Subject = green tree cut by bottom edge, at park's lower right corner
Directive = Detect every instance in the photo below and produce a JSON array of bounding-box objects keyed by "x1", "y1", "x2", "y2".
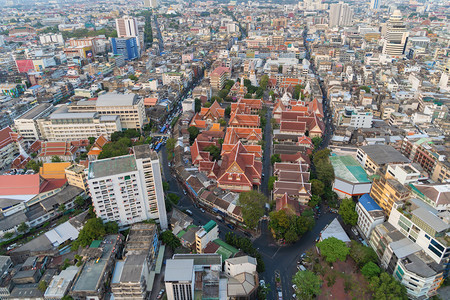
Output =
[{"x1": 369, "y1": 272, "x2": 408, "y2": 300}]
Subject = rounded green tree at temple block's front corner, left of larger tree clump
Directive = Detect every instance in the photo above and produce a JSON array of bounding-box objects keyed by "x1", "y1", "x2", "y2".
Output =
[{"x1": 238, "y1": 191, "x2": 267, "y2": 229}]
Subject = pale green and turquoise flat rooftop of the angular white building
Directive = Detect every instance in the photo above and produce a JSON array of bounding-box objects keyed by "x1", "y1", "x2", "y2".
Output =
[{"x1": 330, "y1": 155, "x2": 370, "y2": 183}]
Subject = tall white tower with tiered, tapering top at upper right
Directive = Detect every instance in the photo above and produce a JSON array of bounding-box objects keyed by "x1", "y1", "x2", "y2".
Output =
[{"x1": 383, "y1": 10, "x2": 409, "y2": 57}]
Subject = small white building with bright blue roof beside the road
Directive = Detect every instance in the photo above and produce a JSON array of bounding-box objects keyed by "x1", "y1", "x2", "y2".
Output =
[{"x1": 356, "y1": 194, "x2": 384, "y2": 238}]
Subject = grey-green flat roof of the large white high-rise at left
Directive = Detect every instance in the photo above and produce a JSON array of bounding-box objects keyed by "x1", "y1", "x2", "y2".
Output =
[{"x1": 88, "y1": 155, "x2": 137, "y2": 179}]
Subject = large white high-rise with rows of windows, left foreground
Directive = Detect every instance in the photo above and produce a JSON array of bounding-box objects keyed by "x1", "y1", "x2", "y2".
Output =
[{"x1": 87, "y1": 145, "x2": 167, "y2": 229}]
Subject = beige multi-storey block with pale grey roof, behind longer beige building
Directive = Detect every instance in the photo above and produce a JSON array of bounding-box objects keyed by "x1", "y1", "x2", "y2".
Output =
[{"x1": 69, "y1": 93, "x2": 147, "y2": 129}]
